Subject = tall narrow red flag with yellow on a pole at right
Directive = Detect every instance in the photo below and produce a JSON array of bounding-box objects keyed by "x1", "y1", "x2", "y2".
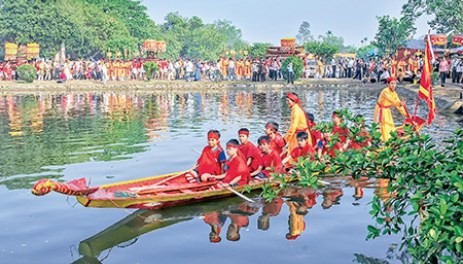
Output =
[{"x1": 418, "y1": 35, "x2": 436, "y2": 125}]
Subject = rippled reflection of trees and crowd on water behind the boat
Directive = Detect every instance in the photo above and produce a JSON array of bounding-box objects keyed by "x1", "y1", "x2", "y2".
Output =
[{"x1": 0, "y1": 88, "x2": 457, "y2": 190}]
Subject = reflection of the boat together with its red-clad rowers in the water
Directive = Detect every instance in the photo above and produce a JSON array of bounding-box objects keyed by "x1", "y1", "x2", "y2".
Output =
[{"x1": 74, "y1": 182, "x2": 406, "y2": 263}]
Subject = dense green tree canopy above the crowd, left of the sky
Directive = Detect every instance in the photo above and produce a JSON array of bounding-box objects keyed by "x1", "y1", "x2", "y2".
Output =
[{"x1": 0, "y1": 0, "x2": 248, "y2": 60}]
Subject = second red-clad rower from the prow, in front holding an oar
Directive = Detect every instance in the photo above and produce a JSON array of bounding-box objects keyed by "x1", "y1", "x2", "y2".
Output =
[{"x1": 201, "y1": 139, "x2": 251, "y2": 189}]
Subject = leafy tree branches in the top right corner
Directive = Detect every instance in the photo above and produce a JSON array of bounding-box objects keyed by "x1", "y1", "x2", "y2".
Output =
[{"x1": 402, "y1": 0, "x2": 463, "y2": 34}]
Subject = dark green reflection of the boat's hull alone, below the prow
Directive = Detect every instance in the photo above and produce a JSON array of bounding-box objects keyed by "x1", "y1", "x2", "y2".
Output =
[{"x1": 74, "y1": 198, "x2": 246, "y2": 263}]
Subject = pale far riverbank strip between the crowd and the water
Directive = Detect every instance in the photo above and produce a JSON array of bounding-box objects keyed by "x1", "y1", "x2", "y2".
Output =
[{"x1": 0, "y1": 79, "x2": 463, "y2": 114}]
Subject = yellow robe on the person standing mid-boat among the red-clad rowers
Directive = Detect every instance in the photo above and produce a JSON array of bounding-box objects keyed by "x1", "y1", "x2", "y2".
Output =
[{"x1": 285, "y1": 104, "x2": 312, "y2": 154}]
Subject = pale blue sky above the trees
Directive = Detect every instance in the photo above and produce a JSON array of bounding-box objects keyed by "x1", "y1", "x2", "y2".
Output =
[{"x1": 142, "y1": 0, "x2": 429, "y2": 46}]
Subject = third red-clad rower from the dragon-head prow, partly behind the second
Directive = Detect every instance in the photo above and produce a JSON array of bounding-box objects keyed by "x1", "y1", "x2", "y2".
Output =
[{"x1": 238, "y1": 128, "x2": 262, "y2": 178}]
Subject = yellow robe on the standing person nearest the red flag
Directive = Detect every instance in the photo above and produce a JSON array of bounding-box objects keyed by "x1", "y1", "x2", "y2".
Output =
[{"x1": 373, "y1": 88, "x2": 406, "y2": 141}]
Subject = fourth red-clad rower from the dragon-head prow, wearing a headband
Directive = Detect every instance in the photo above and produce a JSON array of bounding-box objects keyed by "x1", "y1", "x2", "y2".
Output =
[{"x1": 257, "y1": 136, "x2": 283, "y2": 178}]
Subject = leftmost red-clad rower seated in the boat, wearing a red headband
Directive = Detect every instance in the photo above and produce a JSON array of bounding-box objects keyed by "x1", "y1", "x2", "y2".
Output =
[{"x1": 185, "y1": 130, "x2": 227, "y2": 183}]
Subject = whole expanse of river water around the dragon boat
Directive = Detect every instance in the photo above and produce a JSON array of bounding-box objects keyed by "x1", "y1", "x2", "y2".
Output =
[{"x1": 0, "y1": 87, "x2": 459, "y2": 264}]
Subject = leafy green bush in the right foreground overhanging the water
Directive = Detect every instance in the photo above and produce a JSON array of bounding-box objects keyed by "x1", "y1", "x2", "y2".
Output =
[{"x1": 264, "y1": 107, "x2": 463, "y2": 263}]
